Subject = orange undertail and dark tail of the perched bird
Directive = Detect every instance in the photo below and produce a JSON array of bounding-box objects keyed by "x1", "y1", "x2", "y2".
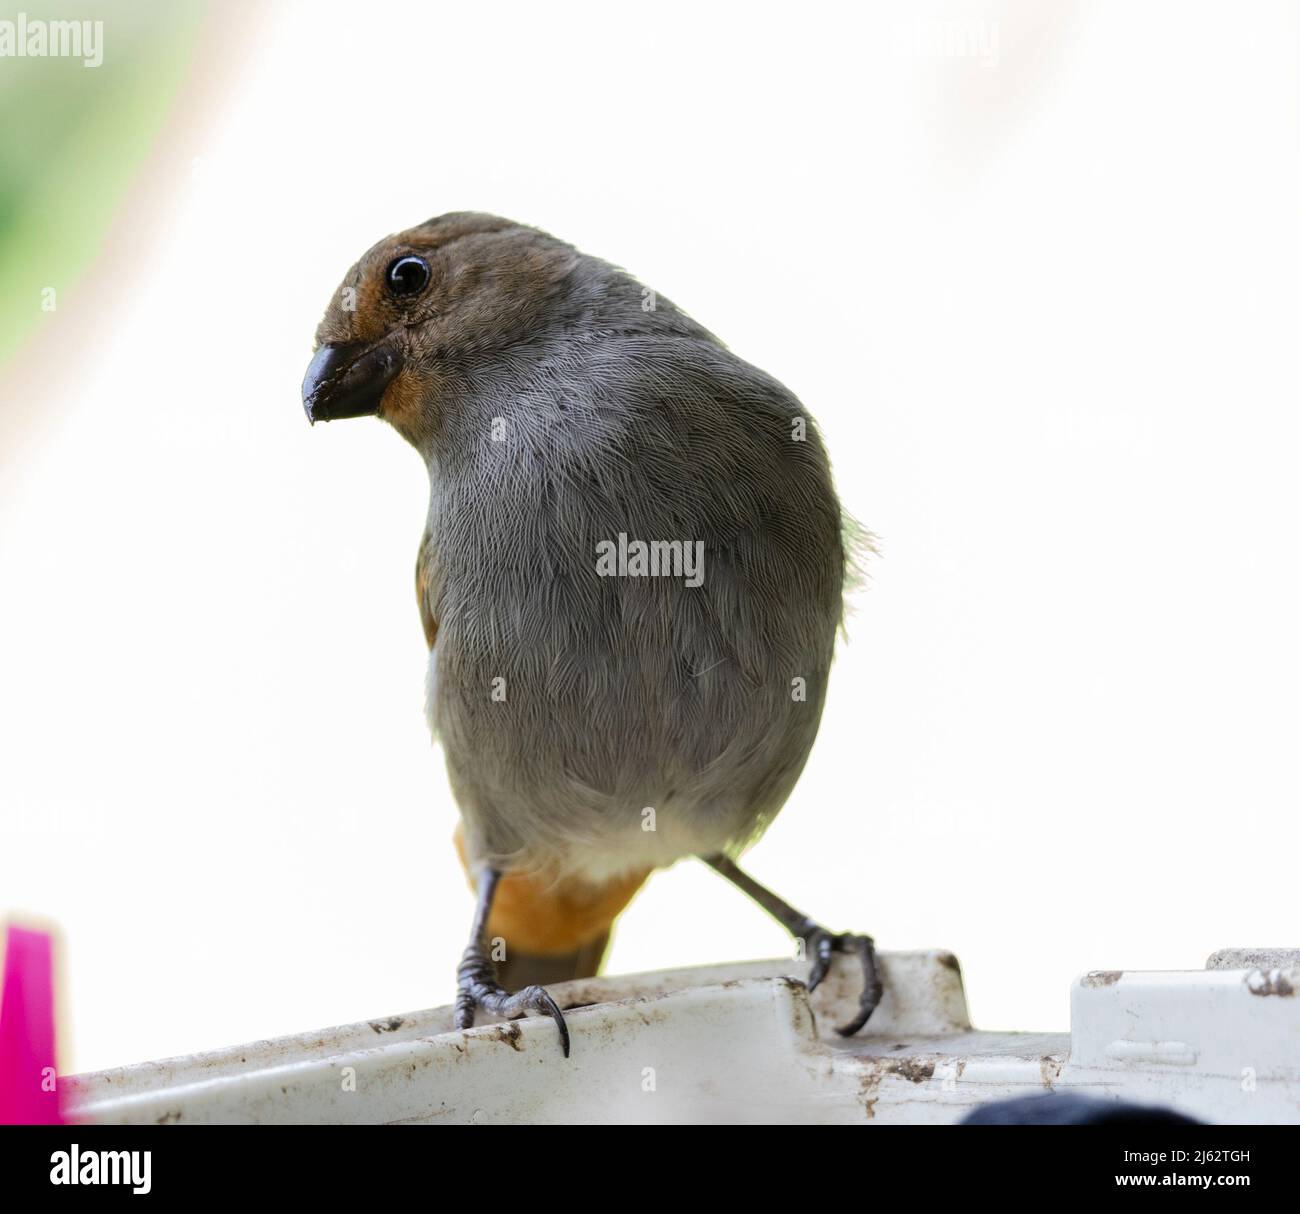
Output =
[{"x1": 455, "y1": 824, "x2": 650, "y2": 990}]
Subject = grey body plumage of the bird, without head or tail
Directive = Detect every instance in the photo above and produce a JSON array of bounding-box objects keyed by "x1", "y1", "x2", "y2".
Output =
[{"x1": 421, "y1": 215, "x2": 844, "y2": 879}]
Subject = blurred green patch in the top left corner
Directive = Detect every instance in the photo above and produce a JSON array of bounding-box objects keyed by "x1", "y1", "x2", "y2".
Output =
[{"x1": 0, "y1": 0, "x2": 207, "y2": 363}]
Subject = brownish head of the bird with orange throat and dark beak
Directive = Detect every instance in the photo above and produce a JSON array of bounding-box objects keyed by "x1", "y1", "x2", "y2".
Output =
[{"x1": 303, "y1": 212, "x2": 579, "y2": 447}]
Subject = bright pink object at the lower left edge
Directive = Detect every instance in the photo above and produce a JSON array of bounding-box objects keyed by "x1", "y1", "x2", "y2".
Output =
[{"x1": 0, "y1": 925, "x2": 62, "y2": 1126}]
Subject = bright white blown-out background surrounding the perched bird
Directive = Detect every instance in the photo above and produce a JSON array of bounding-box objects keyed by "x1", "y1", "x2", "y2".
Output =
[{"x1": 0, "y1": 0, "x2": 1300, "y2": 1070}]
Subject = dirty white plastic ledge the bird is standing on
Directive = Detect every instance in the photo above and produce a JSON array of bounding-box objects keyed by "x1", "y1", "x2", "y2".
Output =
[{"x1": 66, "y1": 953, "x2": 1300, "y2": 1124}]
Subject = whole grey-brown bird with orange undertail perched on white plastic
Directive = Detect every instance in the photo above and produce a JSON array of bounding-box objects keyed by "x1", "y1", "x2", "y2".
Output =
[{"x1": 302, "y1": 212, "x2": 884, "y2": 1057}]
